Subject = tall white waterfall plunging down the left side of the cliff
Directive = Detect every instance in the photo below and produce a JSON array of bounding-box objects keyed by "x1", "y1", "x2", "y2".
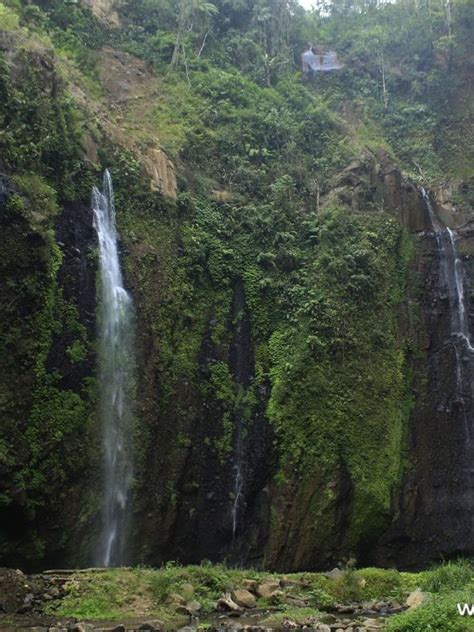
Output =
[{"x1": 92, "y1": 171, "x2": 134, "y2": 566}]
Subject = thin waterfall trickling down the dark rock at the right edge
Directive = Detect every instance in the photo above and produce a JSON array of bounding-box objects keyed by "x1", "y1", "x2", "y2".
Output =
[{"x1": 421, "y1": 188, "x2": 474, "y2": 441}]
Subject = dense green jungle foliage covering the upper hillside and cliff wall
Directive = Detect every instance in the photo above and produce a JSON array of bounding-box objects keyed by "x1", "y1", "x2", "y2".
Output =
[{"x1": 0, "y1": 0, "x2": 474, "y2": 588}]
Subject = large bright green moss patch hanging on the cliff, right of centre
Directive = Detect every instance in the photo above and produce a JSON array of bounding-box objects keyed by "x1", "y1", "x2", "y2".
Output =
[{"x1": 269, "y1": 212, "x2": 410, "y2": 544}]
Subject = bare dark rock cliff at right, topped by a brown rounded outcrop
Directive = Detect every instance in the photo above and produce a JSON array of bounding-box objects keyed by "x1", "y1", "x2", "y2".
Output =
[{"x1": 312, "y1": 156, "x2": 474, "y2": 567}]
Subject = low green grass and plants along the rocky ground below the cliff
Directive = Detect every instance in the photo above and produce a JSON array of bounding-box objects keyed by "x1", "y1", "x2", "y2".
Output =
[{"x1": 40, "y1": 560, "x2": 474, "y2": 632}]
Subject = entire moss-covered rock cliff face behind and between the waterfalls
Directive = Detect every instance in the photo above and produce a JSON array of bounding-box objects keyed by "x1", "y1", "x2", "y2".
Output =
[{"x1": 0, "y1": 2, "x2": 474, "y2": 570}]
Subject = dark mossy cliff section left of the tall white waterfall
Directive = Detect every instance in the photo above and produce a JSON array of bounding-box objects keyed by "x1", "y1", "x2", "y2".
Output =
[{"x1": 0, "y1": 176, "x2": 97, "y2": 566}]
